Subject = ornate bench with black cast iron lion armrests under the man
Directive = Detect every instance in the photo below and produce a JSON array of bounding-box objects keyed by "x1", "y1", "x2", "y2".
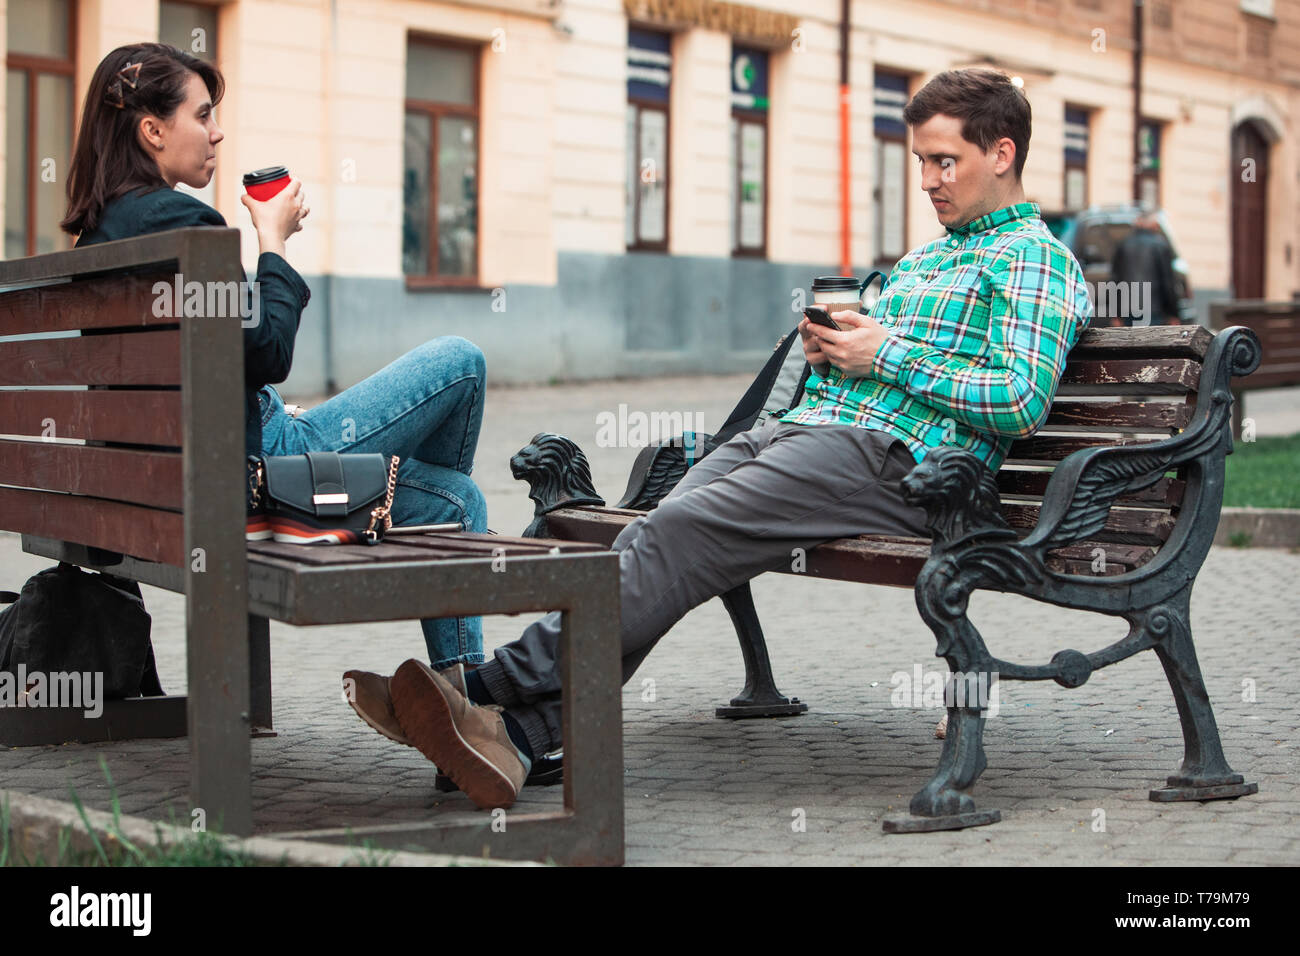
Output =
[{"x1": 514, "y1": 326, "x2": 1260, "y2": 831}]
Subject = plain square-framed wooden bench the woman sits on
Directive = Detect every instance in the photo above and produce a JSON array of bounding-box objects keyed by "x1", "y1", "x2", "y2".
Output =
[{"x1": 0, "y1": 229, "x2": 623, "y2": 864}]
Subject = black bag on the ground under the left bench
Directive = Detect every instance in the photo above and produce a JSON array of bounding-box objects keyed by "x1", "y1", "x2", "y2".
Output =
[{"x1": 0, "y1": 563, "x2": 163, "y2": 705}]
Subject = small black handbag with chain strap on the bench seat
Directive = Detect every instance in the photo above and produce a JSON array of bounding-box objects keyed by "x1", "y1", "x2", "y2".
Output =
[{"x1": 248, "y1": 451, "x2": 400, "y2": 545}]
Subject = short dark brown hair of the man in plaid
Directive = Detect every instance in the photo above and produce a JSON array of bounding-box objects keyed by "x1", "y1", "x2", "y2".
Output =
[{"x1": 902, "y1": 68, "x2": 1032, "y2": 179}]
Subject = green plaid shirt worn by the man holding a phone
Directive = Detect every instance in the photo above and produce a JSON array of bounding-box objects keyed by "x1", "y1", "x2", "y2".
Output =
[{"x1": 781, "y1": 203, "x2": 1092, "y2": 471}]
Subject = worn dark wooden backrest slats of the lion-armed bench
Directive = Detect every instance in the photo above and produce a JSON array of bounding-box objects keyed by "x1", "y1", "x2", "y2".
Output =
[{"x1": 997, "y1": 325, "x2": 1213, "y2": 563}]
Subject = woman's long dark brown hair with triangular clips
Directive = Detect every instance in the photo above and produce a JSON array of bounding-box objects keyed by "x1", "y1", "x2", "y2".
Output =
[{"x1": 59, "y1": 43, "x2": 225, "y2": 235}]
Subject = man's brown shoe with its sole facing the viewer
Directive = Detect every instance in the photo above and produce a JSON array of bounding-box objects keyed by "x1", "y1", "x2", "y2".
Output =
[{"x1": 389, "y1": 659, "x2": 529, "y2": 810}]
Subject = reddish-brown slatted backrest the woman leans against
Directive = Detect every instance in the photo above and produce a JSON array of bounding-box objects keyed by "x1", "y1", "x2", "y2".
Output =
[{"x1": 0, "y1": 229, "x2": 244, "y2": 567}]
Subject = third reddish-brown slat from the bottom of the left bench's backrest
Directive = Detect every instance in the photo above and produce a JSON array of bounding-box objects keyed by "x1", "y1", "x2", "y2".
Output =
[{"x1": 0, "y1": 389, "x2": 183, "y2": 447}]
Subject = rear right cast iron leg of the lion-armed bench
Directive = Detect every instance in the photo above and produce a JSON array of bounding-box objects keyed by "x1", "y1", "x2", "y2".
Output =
[{"x1": 1149, "y1": 587, "x2": 1260, "y2": 803}]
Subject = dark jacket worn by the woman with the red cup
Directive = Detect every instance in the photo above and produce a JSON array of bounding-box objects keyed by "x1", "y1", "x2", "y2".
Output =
[{"x1": 77, "y1": 189, "x2": 311, "y2": 455}]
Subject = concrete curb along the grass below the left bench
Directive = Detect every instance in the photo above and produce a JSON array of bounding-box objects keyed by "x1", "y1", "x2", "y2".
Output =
[{"x1": 0, "y1": 790, "x2": 541, "y2": 866}]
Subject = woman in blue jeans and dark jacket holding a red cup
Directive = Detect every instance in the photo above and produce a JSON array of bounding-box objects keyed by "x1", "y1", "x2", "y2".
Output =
[{"x1": 60, "y1": 43, "x2": 488, "y2": 691}]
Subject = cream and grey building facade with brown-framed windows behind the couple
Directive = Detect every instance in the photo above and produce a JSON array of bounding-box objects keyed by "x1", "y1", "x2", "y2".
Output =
[{"x1": 0, "y1": 0, "x2": 1300, "y2": 394}]
